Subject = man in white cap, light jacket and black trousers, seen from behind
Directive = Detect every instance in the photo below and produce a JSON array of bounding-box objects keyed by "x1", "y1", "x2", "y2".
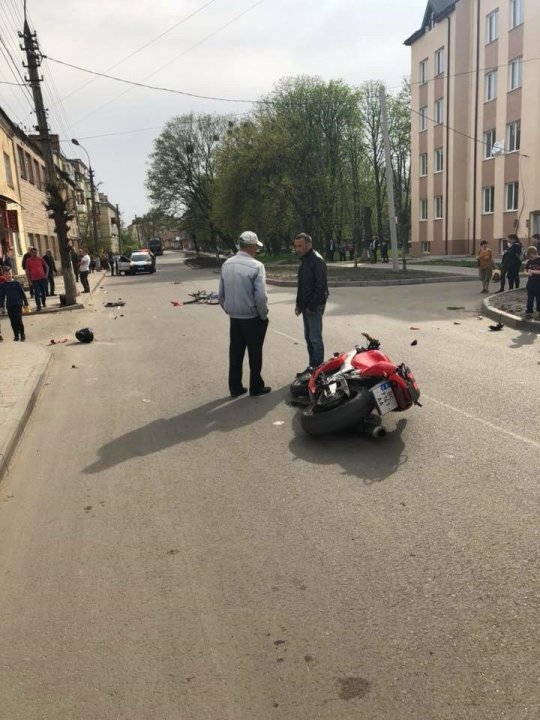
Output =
[{"x1": 219, "y1": 230, "x2": 272, "y2": 398}]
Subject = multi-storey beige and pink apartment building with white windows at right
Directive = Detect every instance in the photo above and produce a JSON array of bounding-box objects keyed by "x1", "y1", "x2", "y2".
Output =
[{"x1": 405, "y1": 0, "x2": 540, "y2": 255}]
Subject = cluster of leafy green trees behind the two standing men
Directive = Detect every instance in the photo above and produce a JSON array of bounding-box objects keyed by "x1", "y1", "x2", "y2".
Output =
[{"x1": 147, "y1": 76, "x2": 410, "y2": 253}]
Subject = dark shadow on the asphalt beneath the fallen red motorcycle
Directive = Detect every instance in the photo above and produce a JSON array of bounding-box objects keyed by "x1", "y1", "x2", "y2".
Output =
[{"x1": 289, "y1": 414, "x2": 408, "y2": 485}]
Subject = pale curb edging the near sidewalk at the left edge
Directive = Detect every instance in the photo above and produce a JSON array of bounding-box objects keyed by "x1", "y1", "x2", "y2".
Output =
[{"x1": 0, "y1": 349, "x2": 52, "y2": 482}]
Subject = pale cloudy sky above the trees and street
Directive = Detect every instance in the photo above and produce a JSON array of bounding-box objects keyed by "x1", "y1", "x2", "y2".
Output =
[{"x1": 0, "y1": 0, "x2": 427, "y2": 224}]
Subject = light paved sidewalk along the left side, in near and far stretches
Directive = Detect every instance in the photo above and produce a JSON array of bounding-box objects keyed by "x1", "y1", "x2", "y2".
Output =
[{"x1": 0, "y1": 272, "x2": 105, "y2": 482}]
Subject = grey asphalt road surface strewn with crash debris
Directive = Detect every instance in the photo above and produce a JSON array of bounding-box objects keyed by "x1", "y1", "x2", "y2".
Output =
[{"x1": 0, "y1": 255, "x2": 540, "y2": 720}]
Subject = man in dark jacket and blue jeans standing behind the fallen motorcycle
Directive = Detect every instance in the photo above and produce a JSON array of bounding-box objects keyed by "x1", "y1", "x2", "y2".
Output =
[{"x1": 294, "y1": 233, "x2": 328, "y2": 375}]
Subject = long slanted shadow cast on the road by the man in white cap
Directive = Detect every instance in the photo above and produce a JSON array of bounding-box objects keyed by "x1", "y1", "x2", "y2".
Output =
[{"x1": 83, "y1": 388, "x2": 288, "y2": 474}]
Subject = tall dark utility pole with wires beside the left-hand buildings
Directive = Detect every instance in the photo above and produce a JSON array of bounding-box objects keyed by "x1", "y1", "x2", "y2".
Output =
[{"x1": 19, "y1": 17, "x2": 77, "y2": 305}]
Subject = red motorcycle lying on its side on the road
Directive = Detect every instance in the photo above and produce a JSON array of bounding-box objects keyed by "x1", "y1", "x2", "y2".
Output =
[{"x1": 290, "y1": 333, "x2": 421, "y2": 437}]
